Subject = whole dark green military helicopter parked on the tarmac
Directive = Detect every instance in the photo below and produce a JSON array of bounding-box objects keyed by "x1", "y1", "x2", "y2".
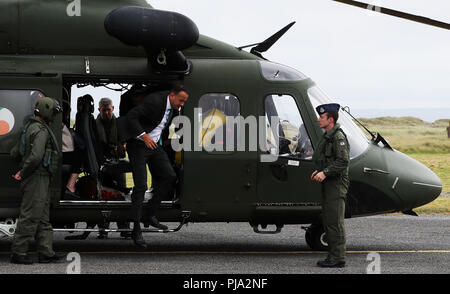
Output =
[{"x1": 0, "y1": 0, "x2": 448, "y2": 249}]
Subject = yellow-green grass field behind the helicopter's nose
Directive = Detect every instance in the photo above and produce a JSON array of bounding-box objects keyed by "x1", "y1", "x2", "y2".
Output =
[{"x1": 360, "y1": 117, "x2": 450, "y2": 214}]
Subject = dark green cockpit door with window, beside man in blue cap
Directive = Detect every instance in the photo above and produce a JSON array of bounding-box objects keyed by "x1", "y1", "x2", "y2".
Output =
[{"x1": 255, "y1": 93, "x2": 321, "y2": 224}]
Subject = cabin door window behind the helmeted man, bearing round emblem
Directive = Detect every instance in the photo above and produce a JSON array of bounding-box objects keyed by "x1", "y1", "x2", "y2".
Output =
[{"x1": 0, "y1": 90, "x2": 44, "y2": 154}]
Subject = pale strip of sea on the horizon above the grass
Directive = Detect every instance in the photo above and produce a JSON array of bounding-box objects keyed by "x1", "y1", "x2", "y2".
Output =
[{"x1": 350, "y1": 108, "x2": 450, "y2": 123}]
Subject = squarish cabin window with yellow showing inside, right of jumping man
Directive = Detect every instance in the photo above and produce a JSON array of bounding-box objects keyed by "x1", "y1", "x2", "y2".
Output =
[{"x1": 198, "y1": 94, "x2": 240, "y2": 152}]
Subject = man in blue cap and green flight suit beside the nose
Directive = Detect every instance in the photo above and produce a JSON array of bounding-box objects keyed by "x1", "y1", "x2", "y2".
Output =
[{"x1": 311, "y1": 103, "x2": 350, "y2": 267}]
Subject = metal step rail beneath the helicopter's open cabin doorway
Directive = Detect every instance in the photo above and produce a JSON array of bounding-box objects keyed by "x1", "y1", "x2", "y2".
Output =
[{"x1": 57, "y1": 211, "x2": 191, "y2": 240}]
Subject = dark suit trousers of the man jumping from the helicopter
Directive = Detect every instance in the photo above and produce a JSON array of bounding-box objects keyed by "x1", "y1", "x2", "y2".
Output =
[{"x1": 127, "y1": 139, "x2": 176, "y2": 223}]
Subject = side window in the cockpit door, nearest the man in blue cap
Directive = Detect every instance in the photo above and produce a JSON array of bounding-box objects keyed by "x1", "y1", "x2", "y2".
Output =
[{"x1": 264, "y1": 95, "x2": 314, "y2": 160}]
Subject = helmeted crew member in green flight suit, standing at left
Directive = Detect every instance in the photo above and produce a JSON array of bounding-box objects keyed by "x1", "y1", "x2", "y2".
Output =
[{"x1": 11, "y1": 97, "x2": 63, "y2": 264}]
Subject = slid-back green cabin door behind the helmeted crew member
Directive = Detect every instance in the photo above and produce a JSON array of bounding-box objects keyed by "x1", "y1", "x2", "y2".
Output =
[{"x1": 0, "y1": 73, "x2": 62, "y2": 209}]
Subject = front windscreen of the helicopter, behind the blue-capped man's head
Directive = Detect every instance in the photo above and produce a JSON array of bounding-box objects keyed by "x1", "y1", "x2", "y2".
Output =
[{"x1": 308, "y1": 86, "x2": 369, "y2": 158}]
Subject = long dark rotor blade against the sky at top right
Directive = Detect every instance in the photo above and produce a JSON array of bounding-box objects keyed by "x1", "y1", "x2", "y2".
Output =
[{"x1": 333, "y1": 0, "x2": 450, "y2": 30}]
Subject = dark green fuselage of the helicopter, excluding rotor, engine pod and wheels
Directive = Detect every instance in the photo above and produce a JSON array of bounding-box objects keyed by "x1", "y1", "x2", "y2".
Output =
[{"x1": 0, "y1": 1, "x2": 442, "y2": 247}]
